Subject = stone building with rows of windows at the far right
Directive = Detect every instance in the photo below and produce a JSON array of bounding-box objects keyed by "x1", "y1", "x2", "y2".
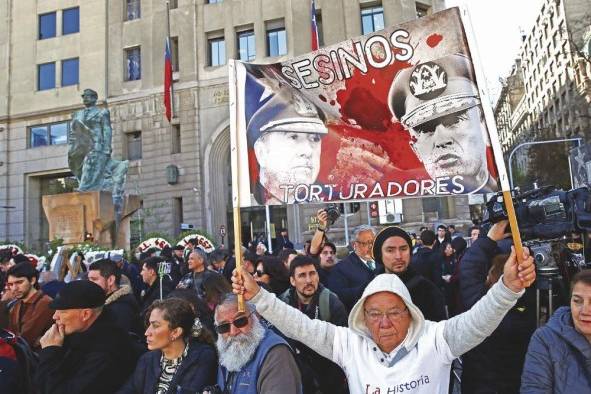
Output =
[{"x1": 495, "y1": 0, "x2": 591, "y2": 175}]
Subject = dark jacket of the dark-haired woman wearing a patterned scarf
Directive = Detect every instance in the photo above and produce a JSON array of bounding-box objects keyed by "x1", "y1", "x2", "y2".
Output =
[{"x1": 117, "y1": 340, "x2": 218, "y2": 394}]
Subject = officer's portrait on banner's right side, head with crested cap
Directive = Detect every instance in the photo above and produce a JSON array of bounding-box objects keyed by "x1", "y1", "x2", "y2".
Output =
[{"x1": 388, "y1": 54, "x2": 497, "y2": 193}]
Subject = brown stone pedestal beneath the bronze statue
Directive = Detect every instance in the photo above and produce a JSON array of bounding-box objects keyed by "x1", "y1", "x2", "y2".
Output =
[{"x1": 43, "y1": 192, "x2": 140, "y2": 249}]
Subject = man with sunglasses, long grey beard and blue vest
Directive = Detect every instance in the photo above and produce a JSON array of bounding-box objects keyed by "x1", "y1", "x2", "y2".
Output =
[{"x1": 215, "y1": 293, "x2": 302, "y2": 394}]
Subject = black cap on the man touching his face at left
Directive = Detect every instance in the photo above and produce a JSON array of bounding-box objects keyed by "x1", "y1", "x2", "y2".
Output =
[{"x1": 49, "y1": 280, "x2": 106, "y2": 310}]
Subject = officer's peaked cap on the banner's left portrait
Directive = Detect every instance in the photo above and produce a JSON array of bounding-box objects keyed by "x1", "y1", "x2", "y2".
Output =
[{"x1": 246, "y1": 88, "x2": 328, "y2": 147}]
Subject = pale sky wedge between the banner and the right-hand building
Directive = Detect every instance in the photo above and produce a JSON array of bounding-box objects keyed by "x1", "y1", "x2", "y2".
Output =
[{"x1": 445, "y1": 0, "x2": 543, "y2": 100}]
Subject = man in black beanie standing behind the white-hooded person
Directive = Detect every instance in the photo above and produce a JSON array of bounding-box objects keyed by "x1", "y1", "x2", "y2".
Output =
[{"x1": 373, "y1": 226, "x2": 447, "y2": 321}]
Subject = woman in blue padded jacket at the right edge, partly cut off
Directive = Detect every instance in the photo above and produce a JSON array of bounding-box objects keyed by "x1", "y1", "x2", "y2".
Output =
[{"x1": 521, "y1": 270, "x2": 591, "y2": 394}]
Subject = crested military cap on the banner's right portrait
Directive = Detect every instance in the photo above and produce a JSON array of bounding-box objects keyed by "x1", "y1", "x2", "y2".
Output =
[{"x1": 388, "y1": 53, "x2": 480, "y2": 128}]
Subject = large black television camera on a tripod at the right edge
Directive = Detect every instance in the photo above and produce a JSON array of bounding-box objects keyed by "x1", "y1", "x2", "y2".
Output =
[{"x1": 483, "y1": 186, "x2": 591, "y2": 324}]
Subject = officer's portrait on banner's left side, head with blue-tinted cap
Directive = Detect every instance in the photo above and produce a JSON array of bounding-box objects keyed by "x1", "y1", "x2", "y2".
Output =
[{"x1": 247, "y1": 87, "x2": 328, "y2": 205}]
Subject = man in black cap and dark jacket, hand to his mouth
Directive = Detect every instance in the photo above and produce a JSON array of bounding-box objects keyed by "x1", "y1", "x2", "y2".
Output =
[{"x1": 35, "y1": 280, "x2": 137, "y2": 394}]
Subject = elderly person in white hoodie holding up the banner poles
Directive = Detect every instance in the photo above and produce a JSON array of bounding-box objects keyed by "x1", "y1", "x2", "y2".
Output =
[{"x1": 232, "y1": 226, "x2": 535, "y2": 394}]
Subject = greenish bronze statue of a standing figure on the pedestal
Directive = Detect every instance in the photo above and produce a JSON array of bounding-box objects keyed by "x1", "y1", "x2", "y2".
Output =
[{"x1": 68, "y1": 89, "x2": 129, "y2": 218}]
